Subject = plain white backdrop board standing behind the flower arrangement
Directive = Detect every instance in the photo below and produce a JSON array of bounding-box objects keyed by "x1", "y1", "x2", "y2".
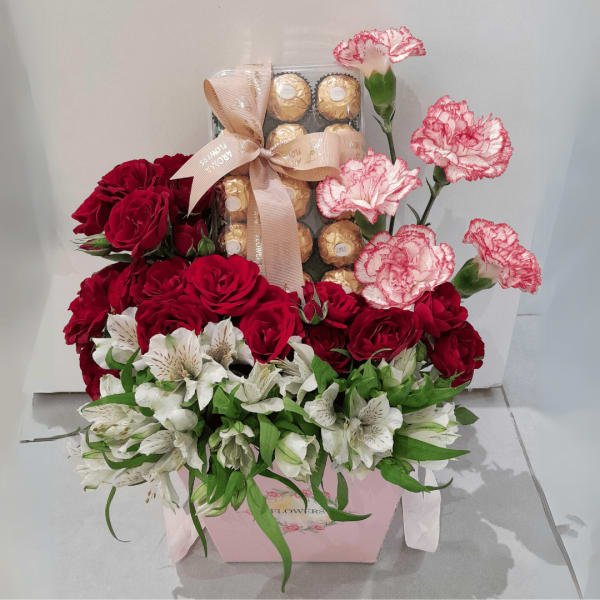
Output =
[{"x1": 2, "y1": 0, "x2": 569, "y2": 391}]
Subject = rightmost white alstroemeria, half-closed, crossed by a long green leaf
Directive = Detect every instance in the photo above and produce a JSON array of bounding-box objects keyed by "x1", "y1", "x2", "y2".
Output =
[{"x1": 402, "y1": 402, "x2": 459, "y2": 471}]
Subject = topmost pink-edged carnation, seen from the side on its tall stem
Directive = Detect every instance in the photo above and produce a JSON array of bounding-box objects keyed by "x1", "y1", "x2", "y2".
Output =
[{"x1": 333, "y1": 27, "x2": 425, "y2": 77}]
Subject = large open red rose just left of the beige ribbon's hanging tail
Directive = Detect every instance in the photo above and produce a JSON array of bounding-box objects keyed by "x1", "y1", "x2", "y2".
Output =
[{"x1": 185, "y1": 254, "x2": 268, "y2": 317}]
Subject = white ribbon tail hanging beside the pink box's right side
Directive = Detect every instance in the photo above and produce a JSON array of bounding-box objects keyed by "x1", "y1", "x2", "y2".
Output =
[{"x1": 402, "y1": 469, "x2": 442, "y2": 552}]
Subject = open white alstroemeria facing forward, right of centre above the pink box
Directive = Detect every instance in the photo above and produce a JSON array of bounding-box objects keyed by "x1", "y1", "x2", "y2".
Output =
[{"x1": 321, "y1": 389, "x2": 402, "y2": 469}]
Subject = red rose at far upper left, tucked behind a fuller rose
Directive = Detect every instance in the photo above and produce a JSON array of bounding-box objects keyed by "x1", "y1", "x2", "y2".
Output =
[{"x1": 71, "y1": 159, "x2": 163, "y2": 235}]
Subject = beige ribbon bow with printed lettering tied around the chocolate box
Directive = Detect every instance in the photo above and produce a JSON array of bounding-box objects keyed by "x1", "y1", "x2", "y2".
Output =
[{"x1": 172, "y1": 63, "x2": 365, "y2": 291}]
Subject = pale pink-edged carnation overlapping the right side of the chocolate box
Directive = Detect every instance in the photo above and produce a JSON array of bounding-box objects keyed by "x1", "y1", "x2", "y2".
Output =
[{"x1": 317, "y1": 148, "x2": 422, "y2": 223}]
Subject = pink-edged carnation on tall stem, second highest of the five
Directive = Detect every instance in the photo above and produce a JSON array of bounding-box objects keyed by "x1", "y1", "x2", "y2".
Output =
[{"x1": 410, "y1": 96, "x2": 513, "y2": 183}]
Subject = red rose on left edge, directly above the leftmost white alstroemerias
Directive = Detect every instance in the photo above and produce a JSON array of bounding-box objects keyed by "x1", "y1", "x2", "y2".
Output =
[{"x1": 63, "y1": 263, "x2": 125, "y2": 344}]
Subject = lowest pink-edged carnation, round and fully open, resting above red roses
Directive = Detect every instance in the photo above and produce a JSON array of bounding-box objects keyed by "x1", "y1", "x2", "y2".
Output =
[{"x1": 354, "y1": 225, "x2": 454, "y2": 308}]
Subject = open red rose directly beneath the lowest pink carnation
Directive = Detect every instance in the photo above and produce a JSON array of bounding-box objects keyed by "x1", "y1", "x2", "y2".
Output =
[{"x1": 348, "y1": 308, "x2": 423, "y2": 360}]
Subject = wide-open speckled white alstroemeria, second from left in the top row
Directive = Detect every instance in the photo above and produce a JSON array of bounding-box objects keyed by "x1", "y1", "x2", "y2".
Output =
[{"x1": 144, "y1": 327, "x2": 227, "y2": 410}]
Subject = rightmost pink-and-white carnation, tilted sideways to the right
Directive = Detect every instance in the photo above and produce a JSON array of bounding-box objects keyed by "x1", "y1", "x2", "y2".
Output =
[{"x1": 463, "y1": 219, "x2": 542, "y2": 294}]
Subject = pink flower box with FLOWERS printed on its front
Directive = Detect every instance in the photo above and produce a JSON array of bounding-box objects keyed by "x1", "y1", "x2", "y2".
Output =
[{"x1": 197, "y1": 466, "x2": 402, "y2": 563}]
